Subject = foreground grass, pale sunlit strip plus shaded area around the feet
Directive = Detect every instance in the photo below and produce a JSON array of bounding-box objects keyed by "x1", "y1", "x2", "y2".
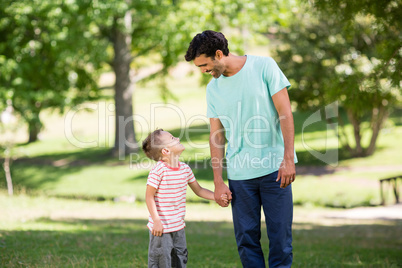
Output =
[{"x1": 0, "y1": 192, "x2": 402, "y2": 268}]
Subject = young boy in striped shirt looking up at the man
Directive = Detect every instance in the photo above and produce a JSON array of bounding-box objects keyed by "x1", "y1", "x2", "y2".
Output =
[{"x1": 142, "y1": 129, "x2": 227, "y2": 268}]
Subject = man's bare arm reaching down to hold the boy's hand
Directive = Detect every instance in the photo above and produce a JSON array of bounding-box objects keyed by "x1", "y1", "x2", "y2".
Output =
[{"x1": 209, "y1": 118, "x2": 232, "y2": 207}]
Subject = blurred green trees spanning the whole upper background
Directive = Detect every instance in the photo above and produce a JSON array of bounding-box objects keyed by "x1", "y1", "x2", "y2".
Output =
[{"x1": 0, "y1": 0, "x2": 402, "y2": 157}]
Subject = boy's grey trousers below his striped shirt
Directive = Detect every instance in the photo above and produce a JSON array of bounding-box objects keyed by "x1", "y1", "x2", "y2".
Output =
[{"x1": 148, "y1": 229, "x2": 188, "y2": 268}]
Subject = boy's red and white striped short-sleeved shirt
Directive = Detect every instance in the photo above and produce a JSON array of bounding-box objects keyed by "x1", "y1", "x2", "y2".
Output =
[{"x1": 147, "y1": 161, "x2": 196, "y2": 233}]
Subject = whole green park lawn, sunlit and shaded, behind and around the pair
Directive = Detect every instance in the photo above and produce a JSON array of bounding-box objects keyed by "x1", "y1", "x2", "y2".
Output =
[{"x1": 0, "y1": 72, "x2": 402, "y2": 267}]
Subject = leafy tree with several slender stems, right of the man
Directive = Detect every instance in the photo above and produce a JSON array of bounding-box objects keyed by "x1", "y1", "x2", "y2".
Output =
[{"x1": 276, "y1": 4, "x2": 401, "y2": 156}]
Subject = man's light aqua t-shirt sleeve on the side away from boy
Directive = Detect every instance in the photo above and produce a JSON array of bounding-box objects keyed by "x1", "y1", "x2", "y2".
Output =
[{"x1": 263, "y1": 57, "x2": 290, "y2": 96}]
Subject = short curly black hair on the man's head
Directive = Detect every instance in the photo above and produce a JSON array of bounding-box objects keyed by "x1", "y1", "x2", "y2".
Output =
[{"x1": 184, "y1": 30, "x2": 229, "y2": 61}]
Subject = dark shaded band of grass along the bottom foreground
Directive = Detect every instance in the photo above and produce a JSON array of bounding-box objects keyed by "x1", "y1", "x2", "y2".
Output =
[{"x1": 0, "y1": 218, "x2": 402, "y2": 267}]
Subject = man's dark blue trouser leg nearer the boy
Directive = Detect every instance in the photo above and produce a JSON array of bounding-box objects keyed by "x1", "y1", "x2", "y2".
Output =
[{"x1": 229, "y1": 178, "x2": 265, "y2": 268}]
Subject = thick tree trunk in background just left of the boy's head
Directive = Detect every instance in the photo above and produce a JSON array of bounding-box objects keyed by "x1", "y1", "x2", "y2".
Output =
[{"x1": 112, "y1": 11, "x2": 138, "y2": 159}]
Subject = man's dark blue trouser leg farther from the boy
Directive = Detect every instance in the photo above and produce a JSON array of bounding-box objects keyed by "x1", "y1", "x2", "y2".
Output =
[{"x1": 261, "y1": 172, "x2": 293, "y2": 268}]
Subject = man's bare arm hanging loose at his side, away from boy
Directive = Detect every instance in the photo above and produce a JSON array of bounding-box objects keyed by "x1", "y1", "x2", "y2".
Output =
[{"x1": 272, "y1": 88, "x2": 296, "y2": 188}]
